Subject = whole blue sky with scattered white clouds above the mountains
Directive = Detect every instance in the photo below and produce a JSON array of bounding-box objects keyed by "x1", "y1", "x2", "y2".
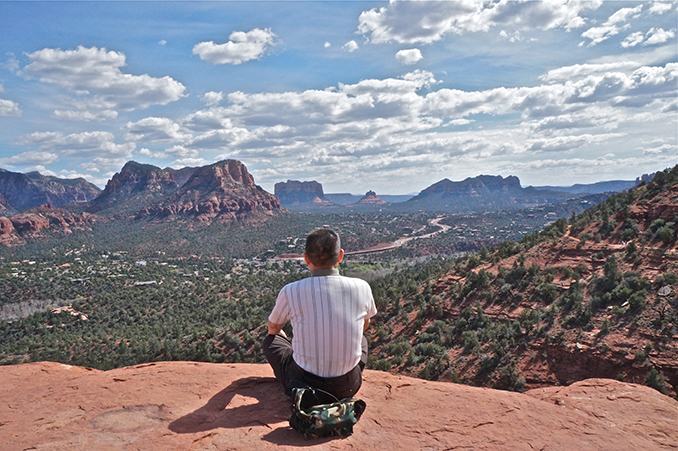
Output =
[{"x1": 0, "y1": 0, "x2": 678, "y2": 194}]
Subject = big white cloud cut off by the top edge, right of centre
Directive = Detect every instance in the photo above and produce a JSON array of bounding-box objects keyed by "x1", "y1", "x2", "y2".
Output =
[{"x1": 358, "y1": 0, "x2": 602, "y2": 44}]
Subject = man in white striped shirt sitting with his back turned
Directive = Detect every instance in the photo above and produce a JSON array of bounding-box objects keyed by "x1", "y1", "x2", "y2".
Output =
[{"x1": 263, "y1": 229, "x2": 377, "y2": 399}]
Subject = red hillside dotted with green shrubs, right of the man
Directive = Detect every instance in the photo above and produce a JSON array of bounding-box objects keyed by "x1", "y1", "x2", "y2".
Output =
[{"x1": 372, "y1": 166, "x2": 678, "y2": 395}]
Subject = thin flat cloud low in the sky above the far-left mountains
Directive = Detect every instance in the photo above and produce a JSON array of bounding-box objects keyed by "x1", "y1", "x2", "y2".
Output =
[{"x1": 17, "y1": 132, "x2": 136, "y2": 158}]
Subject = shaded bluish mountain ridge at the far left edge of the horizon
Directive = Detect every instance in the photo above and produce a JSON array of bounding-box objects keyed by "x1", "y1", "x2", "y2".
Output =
[{"x1": 0, "y1": 169, "x2": 101, "y2": 213}]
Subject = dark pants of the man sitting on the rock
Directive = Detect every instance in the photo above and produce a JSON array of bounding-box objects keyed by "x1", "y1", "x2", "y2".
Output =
[{"x1": 263, "y1": 334, "x2": 367, "y2": 399}]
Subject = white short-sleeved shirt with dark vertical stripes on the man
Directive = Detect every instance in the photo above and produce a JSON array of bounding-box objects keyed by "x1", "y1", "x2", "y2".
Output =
[{"x1": 268, "y1": 269, "x2": 377, "y2": 377}]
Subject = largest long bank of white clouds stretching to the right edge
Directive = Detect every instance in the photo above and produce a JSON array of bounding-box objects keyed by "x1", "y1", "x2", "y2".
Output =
[{"x1": 159, "y1": 61, "x2": 678, "y2": 191}]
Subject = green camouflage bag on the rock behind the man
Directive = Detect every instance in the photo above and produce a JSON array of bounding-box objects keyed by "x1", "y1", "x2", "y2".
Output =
[{"x1": 290, "y1": 387, "x2": 367, "y2": 439}]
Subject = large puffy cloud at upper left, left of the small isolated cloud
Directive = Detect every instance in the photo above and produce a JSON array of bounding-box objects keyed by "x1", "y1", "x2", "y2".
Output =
[{"x1": 21, "y1": 46, "x2": 186, "y2": 119}]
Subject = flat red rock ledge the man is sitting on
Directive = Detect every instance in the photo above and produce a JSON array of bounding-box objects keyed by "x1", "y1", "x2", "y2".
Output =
[{"x1": 0, "y1": 362, "x2": 678, "y2": 451}]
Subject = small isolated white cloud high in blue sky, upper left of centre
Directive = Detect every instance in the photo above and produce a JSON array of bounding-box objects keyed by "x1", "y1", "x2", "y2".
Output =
[{"x1": 193, "y1": 28, "x2": 276, "y2": 64}]
